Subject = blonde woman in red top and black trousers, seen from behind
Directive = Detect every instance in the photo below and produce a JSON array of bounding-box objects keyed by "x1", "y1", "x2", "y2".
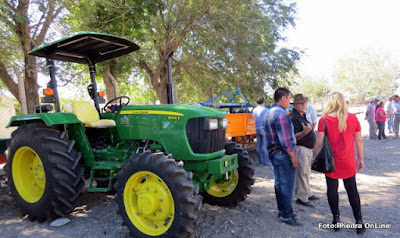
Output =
[{"x1": 314, "y1": 92, "x2": 365, "y2": 234}]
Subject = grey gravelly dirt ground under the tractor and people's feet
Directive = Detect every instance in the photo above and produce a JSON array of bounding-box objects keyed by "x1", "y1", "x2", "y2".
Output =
[{"x1": 0, "y1": 109, "x2": 400, "y2": 238}]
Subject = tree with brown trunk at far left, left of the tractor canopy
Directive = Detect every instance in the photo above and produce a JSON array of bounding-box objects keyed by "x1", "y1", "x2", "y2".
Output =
[{"x1": 0, "y1": 0, "x2": 71, "y2": 113}]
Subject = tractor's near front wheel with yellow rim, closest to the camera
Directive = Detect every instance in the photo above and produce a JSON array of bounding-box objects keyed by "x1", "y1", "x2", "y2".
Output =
[{"x1": 115, "y1": 152, "x2": 202, "y2": 237}]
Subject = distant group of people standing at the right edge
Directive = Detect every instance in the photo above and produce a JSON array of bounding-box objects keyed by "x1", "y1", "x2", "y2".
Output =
[{"x1": 365, "y1": 95, "x2": 400, "y2": 140}]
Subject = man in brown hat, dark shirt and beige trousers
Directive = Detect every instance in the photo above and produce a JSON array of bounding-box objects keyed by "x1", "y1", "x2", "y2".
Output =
[{"x1": 289, "y1": 94, "x2": 318, "y2": 207}]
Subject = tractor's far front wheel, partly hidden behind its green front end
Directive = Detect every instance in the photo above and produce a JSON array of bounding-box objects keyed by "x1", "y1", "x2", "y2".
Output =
[{"x1": 202, "y1": 142, "x2": 254, "y2": 207}]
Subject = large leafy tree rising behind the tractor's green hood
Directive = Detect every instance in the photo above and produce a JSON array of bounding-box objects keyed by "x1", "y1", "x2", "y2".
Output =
[{"x1": 139, "y1": 0, "x2": 299, "y2": 103}]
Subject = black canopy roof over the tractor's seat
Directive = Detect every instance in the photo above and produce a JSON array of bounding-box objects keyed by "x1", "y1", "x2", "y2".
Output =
[{"x1": 29, "y1": 32, "x2": 139, "y2": 65}]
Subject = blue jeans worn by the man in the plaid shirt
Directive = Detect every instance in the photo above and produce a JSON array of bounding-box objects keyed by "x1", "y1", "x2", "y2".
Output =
[{"x1": 271, "y1": 152, "x2": 296, "y2": 220}]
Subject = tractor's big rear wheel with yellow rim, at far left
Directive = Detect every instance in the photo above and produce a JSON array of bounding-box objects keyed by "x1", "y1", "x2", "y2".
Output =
[{"x1": 5, "y1": 123, "x2": 85, "y2": 222}]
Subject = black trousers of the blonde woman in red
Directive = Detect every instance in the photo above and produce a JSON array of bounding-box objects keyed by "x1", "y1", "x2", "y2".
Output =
[{"x1": 325, "y1": 175, "x2": 362, "y2": 221}]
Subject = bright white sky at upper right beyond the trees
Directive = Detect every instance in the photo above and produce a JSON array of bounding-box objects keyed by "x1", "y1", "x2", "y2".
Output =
[{"x1": 284, "y1": 0, "x2": 400, "y2": 78}]
